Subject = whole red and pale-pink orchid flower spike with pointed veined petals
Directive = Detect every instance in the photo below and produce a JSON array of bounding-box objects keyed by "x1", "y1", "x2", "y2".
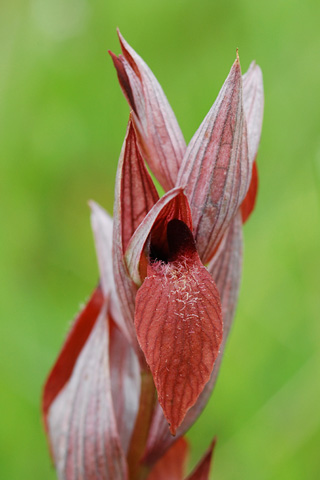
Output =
[{"x1": 43, "y1": 33, "x2": 263, "y2": 480}]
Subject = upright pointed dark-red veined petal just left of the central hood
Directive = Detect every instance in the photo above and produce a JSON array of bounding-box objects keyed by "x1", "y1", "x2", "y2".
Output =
[{"x1": 112, "y1": 119, "x2": 159, "y2": 352}]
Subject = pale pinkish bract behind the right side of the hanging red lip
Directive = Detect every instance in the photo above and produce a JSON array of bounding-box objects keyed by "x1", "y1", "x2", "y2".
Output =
[{"x1": 144, "y1": 212, "x2": 242, "y2": 465}]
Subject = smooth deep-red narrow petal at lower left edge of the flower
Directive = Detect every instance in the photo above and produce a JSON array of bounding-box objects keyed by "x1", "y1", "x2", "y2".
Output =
[{"x1": 42, "y1": 286, "x2": 104, "y2": 430}]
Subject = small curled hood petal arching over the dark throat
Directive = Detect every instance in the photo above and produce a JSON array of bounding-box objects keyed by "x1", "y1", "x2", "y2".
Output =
[{"x1": 125, "y1": 187, "x2": 192, "y2": 285}]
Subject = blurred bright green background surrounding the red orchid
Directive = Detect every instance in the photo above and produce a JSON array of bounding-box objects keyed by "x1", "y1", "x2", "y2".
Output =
[{"x1": 0, "y1": 0, "x2": 320, "y2": 480}]
